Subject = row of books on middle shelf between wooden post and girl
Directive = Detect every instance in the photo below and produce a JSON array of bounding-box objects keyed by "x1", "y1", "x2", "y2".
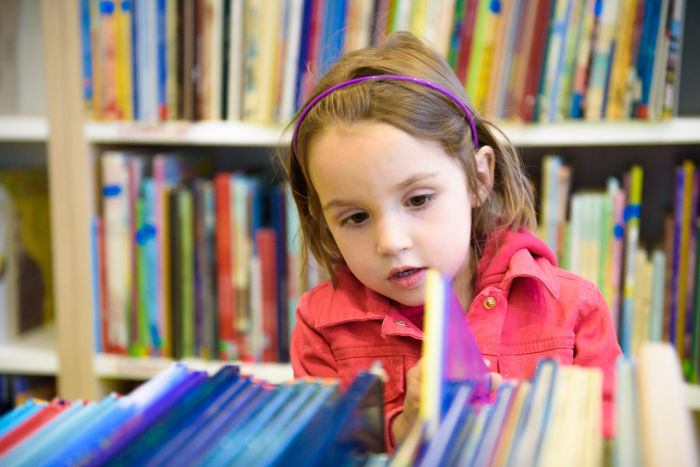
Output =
[{"x1": 93, "y1": 151, "x2": 306, "y2": 361}]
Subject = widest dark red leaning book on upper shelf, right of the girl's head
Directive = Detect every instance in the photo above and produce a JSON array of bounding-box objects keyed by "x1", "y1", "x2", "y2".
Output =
[{"x1": 519, "y1": 0, "x2": 552, "y2": 122}]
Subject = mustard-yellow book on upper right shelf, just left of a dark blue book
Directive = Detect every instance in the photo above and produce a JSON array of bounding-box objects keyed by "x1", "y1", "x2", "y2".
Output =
[{"x1": 605, "y1": 0, "x2": 637, "y2": 119}]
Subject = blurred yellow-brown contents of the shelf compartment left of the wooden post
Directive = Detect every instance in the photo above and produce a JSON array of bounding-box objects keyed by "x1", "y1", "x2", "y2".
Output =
[{"x1": 0, "y1": 168, "x2": 53, "y2": 343}]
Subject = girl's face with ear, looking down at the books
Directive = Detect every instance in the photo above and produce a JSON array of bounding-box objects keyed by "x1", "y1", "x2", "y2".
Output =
[{"x1": 308, "y1": 122, "x2": 493, "y2": 306}]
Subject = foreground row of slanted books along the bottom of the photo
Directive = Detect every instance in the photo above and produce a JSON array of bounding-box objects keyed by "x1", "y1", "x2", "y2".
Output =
[{"x1": 0, "y1": 344, "x2": 698, "y2": 466}]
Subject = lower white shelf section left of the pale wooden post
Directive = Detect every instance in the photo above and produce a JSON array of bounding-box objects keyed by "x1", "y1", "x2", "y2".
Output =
[{"x1": 0, "y1": 324, "x2": 58, "y2": 376}]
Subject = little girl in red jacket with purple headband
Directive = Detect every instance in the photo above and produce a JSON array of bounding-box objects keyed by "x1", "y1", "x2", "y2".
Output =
[{"x1": 286, "y1": 32, "x2": 620, "y2": 450}]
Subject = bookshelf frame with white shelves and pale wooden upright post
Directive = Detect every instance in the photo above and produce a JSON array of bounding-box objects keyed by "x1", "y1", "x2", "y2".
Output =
[{"x1": 0, "y1": 0, "x2": 700, "y2": 432}]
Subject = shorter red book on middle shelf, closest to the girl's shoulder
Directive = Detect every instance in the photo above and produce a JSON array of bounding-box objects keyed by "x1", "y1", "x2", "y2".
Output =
[{"x1": 255, "y1": 228, "x2": 279, "y2": 362}]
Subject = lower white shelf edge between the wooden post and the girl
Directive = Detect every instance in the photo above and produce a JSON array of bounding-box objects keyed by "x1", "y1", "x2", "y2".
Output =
[{"x1": 94, "y1": 354, "x2": 293, "y2": 384}]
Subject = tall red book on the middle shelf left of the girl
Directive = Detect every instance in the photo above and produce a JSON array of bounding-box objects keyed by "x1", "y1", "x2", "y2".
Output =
[{"x1": 214, "y1": 173, "x2": 235, "y2": 360}]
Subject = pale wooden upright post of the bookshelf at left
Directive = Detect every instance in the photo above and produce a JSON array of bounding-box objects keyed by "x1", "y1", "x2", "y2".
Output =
[{"x1": 37, "y1": 0, "x2": 98, "y2": 400}]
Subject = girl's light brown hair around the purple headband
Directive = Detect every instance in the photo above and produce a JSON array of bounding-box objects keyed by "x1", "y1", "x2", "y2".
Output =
[{"x1": 278, "y1": 32, "x2": 536, "y2": 283}]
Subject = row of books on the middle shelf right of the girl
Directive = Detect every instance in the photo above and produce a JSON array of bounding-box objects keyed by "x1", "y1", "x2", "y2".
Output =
[{"x1": 539, "y1": 156, "x2": 700, "y2": 382}]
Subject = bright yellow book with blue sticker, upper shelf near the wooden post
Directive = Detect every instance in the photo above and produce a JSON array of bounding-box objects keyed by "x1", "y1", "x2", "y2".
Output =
[{"x1": 114, "y1": 1, "x2": 134, "y2": 120}]
